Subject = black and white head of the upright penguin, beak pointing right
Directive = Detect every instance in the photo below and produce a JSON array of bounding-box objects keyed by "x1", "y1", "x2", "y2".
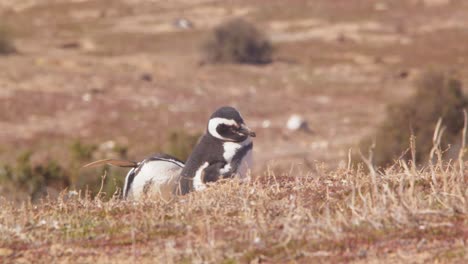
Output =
[{"x1": 207, "y1": 106, "x2": 255, "y2": 142}]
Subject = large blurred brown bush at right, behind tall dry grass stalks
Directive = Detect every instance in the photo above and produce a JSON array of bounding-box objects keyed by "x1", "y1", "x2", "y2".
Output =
[{"x1": 360, "y1": 72, "x2": 468, "y2": 166}]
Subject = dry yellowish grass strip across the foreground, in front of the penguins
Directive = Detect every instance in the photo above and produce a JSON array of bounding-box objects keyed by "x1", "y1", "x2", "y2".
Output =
[{"x1": 0, "y1": 155, "x2": 468, "y2": 263}]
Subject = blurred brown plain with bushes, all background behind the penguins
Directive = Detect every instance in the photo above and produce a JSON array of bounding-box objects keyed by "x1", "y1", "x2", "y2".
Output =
[{"x1": 0, "y1": 0, "x2": 468, "y2": 201}]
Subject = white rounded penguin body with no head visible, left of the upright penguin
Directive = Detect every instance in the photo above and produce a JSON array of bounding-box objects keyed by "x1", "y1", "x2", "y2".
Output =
[{"x1": 83, "y1": 153, "x2": 184, "y2": 201}]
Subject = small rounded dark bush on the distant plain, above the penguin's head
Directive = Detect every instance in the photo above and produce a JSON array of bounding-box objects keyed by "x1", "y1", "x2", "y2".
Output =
[{"x1": 203, "y1": 19, "x2": 273, "y2": 64}]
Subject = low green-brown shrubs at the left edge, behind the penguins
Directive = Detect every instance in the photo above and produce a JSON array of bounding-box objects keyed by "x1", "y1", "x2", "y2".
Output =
[{"x1": 0, "y1": 140, "x2": 127, "y2": 201}]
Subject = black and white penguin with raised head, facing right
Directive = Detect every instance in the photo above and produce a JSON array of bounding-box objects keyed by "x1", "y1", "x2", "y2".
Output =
[{"x1": 178, "y1": 106, "x2": 255, "y2": 195}]
